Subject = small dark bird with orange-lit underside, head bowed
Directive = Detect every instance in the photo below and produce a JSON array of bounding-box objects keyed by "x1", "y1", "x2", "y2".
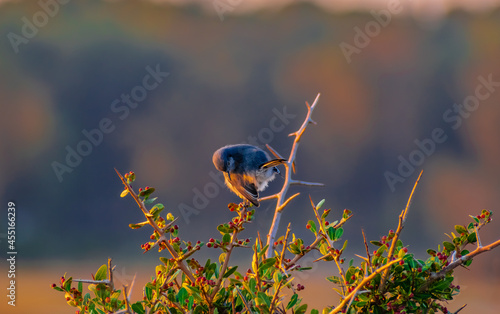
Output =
[{"x1": 212, "y1": 144, "x2": 286, "y2": 207}]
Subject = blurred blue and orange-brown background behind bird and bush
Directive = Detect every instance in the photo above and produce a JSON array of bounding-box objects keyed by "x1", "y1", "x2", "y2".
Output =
[{"x1": 0, "y1": 0, "x2": 500, "y2": 313}]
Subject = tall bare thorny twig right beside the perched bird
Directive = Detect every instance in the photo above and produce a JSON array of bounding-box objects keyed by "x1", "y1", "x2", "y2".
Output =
[{"x1": 261, "y1": 94, "x2": 323, "y2": 258}]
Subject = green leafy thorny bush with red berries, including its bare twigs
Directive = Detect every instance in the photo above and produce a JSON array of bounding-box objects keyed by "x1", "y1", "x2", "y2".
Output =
[{"x1": 52, "y1": 95, "x2": 500, "y2": 314}]
